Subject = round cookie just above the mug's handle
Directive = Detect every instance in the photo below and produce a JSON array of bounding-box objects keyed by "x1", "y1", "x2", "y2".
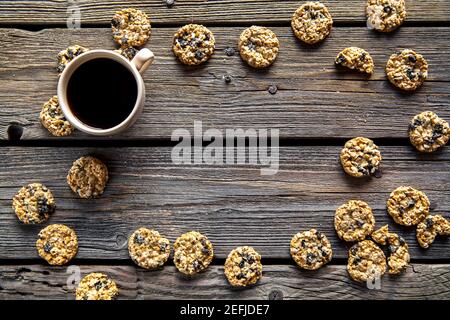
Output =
[{"x1": 111, "y1": 8, "x2": 152, "y2": 47}]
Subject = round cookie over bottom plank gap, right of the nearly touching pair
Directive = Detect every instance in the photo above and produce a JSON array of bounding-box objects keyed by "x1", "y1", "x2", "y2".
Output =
[{"x1": 225, "y1": 246, "x2": 262, "y2": 287}]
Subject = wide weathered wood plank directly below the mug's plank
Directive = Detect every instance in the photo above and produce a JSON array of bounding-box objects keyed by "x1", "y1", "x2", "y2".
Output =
[{"x1": 0, "y1": 146, "x2": 450, "y2": 260}]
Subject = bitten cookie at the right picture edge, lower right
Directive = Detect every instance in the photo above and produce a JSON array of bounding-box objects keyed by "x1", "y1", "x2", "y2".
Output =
[{"x1": 416, "y1": 214, "x2": 450, "y2": 249}]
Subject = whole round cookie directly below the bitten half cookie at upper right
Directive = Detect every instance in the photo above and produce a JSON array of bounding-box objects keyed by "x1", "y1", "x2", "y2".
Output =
[{"x1": 340, "y1": 137, "x2": 382, "y2": 178}]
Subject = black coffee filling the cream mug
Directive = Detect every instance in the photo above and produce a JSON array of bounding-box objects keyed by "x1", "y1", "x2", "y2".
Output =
[{"x1": 67, "y1": 58, "x2": 138, "y2": 129}]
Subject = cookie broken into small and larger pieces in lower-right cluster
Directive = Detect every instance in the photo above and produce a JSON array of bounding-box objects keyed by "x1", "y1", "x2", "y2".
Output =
[{"x1": 372, "y1": 225, "x2": 410, "y2": 274}]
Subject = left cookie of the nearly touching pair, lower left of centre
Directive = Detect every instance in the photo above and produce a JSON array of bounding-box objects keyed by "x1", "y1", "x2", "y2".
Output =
[{"x1": 128, "y1": 228, "x2": 170, "y2": 270}]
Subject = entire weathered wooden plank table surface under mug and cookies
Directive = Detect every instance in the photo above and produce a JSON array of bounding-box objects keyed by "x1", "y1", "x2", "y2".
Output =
[{"x1": 0, "y1": 0, "x2": 450, "y2": 299}]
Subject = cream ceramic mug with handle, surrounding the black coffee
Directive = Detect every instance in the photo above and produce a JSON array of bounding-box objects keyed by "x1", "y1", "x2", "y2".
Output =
[{"x1": 58, "y1": 49, "x2": 154, "y2": 136}]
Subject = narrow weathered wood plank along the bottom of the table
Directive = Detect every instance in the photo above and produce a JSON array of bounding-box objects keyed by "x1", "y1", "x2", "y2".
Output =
[{"x1": 0, "y1": 261, "x2": 450, "y2": 300}]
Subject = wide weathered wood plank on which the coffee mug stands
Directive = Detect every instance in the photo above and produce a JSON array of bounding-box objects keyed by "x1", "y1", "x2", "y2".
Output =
[{"x1": 0, "y1": 27, "x2": 450, "y2": 139}]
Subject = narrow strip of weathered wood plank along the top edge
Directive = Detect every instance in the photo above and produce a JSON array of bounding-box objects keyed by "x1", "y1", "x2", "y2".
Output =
[{"x1": 0, "y1": 0, "x2": 450, "y2": 25}]
